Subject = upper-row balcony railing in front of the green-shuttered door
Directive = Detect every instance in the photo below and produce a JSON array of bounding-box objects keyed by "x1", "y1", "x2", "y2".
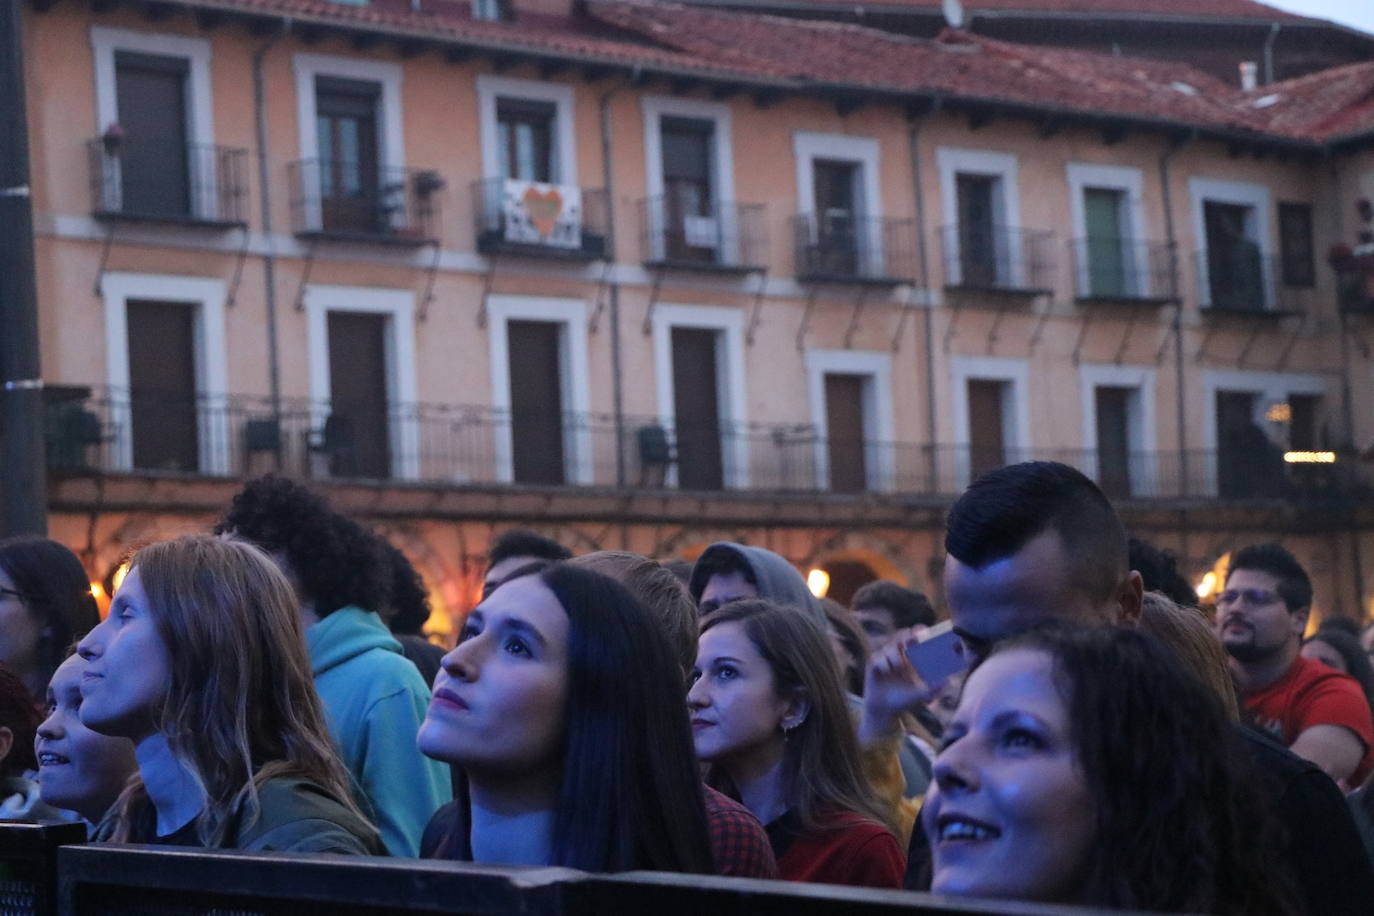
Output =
[{"x1": 1069, "y1": 238, "x2": 1179, "y2": 305}]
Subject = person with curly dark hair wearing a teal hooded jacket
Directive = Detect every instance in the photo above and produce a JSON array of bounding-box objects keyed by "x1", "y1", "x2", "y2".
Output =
[{"x1": 216, "y1": 477, "x2": 453, "y2": 858}]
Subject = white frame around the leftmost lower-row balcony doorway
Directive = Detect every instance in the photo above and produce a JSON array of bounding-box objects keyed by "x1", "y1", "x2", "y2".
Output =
[{"x1": 100, "y1": 272, "x2": 231, "y2": 475}]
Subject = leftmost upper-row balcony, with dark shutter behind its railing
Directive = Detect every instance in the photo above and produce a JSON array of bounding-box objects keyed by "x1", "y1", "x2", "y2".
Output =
[{"x1": 87, "y1": 137, "x2": 247, "y2": 229}]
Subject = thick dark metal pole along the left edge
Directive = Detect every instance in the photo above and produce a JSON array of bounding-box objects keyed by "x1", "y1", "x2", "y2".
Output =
[{"x1": 0, "y1": 1, "x2": 48, "y2": 536}]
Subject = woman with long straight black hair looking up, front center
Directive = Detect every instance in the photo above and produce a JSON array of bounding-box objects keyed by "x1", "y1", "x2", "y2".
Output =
[{"x1": 419, "y1": 564, "x2": 713, "y2": 873}]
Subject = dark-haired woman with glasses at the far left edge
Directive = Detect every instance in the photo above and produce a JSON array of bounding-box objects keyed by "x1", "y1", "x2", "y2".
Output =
[{"x1": 0, "y1": 536, "x2": 100, "y2": 703}]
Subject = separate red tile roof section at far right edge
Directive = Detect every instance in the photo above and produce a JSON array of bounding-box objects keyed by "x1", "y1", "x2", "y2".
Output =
[{"x1": 1238, "y1": 60, "x2": 1374, "y2": 143}]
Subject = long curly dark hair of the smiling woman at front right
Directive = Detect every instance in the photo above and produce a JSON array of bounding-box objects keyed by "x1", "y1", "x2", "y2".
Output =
[{"x1": 993, "y1": 625, "x2": 1297, "y2": 916}]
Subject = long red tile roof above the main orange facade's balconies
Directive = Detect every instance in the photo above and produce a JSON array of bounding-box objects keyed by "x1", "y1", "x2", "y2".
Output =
[{"x1": 139, "y1": 0, "x2": 1330, "y2": 141}]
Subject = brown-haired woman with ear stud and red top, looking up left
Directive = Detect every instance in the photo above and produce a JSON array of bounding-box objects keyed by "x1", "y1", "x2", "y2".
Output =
[{"x1": 687, "y1": 600, "x2": 905, "y2": 887}]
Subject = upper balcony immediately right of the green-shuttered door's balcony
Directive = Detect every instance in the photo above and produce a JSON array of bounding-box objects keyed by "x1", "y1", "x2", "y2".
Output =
[{"x1": 1193, "y1": 242, "x2": 1315, "y2": 317}]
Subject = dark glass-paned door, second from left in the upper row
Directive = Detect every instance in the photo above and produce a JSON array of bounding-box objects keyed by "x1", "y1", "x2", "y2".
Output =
[{"x1": 316, "y1": 77, "x2": 383, "y2": 233}]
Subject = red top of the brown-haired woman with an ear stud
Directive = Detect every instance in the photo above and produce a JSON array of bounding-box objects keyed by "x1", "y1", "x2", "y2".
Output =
[{"x1": 768, "y1": 812, "x2": 907, "y2": 889}]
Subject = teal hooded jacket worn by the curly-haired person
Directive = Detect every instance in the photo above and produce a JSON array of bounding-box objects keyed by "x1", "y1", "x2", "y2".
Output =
[{"x1": 305, "y1": 607, "x2": 453, "y2": 857}]
